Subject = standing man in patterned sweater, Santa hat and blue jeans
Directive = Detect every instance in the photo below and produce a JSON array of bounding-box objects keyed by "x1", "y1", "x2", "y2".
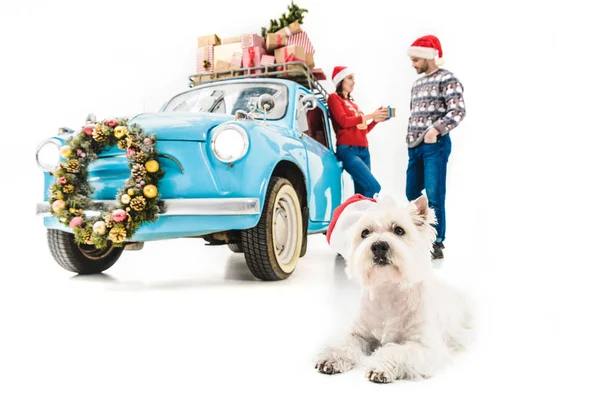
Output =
[{"x1": 406, "y1": 35, "x2": 466, "y2": 258}]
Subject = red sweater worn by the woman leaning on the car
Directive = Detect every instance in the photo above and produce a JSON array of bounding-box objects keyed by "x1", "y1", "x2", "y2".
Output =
[{"x1": 327, "y1": 93, "x2": 377, "y2": 147}]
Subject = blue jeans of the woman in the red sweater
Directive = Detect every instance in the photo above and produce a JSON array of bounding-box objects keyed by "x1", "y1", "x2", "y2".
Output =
[{"x1": 336, "y1": 145, "x2": 381, "y2": 197}]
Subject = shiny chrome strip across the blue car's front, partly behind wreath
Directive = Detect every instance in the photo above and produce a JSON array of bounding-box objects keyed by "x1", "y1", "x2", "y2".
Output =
[{"x1": 35, "y1": 198, "x2": 260, "y2": 217}]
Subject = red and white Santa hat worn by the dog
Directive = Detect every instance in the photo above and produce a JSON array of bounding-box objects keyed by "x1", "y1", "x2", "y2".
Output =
[{"x1": 327, "y1": 194, "x2": 377, "y2": 258}]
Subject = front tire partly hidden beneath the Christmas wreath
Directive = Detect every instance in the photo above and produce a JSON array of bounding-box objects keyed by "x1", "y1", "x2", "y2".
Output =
[{"x1": 47, "y1": 229, "x2": 124, "y2": 275}]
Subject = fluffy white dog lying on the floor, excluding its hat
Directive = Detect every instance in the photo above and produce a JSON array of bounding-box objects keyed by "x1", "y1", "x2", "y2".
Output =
[{"x1": 315, "y1": 196, "x2": 472, "y2": 383}]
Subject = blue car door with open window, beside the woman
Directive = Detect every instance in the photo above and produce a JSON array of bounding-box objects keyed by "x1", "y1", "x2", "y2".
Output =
[{"x1": 295, "y1": 92, "x2": 342, "y2": 222}]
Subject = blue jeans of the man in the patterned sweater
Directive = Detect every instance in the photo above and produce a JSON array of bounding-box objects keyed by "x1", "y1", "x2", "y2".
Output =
[{"x1": 406, "y1": 134, "x2": 452, "y2": 242}]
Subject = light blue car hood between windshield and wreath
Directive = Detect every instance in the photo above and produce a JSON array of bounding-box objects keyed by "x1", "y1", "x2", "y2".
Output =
[{"x1": 130, "y1": 112, "x2": 234, "y2": 142}]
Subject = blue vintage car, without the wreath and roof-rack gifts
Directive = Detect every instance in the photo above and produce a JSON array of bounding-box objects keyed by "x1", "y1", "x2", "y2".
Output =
[{"x1": 36, "y1": 64, "x2": 342, "y2": 281}]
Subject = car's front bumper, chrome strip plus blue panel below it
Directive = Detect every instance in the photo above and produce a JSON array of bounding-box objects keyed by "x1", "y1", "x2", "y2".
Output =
[{"x1": 36, "y1": 198, "x2": 261, "y2": 242}]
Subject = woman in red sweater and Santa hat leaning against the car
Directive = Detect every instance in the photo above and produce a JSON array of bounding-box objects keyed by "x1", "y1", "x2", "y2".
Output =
[{"x1": 327, "y1": 67, "x2": 388, "y2": 197}]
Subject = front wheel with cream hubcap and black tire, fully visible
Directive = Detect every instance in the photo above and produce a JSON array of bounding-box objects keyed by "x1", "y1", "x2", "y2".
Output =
[{"x1": 242, "y1": 177, "x2": 304, "y2": 281}]
